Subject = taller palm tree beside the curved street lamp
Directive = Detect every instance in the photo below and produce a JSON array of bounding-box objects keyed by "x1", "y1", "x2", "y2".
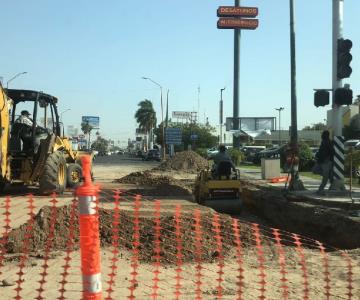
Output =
[{"x1": 135, "y1": 99, "x2": 156, "y2": 148}]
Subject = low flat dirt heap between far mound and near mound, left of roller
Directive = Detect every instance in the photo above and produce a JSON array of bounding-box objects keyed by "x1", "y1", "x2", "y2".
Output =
[{"x1": 114, "y1": 171, "x2": 192, "y2": 196}]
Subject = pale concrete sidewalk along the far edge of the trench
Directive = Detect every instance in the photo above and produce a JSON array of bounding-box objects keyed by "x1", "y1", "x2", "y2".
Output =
[{"x1": 239, "y1": 167, "x2": 360, "y2": 211}]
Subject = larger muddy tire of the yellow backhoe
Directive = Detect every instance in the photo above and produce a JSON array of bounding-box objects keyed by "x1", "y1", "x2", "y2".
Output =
[{"x1": 39, "y1": 151, "x2": 67, "y2": 194}]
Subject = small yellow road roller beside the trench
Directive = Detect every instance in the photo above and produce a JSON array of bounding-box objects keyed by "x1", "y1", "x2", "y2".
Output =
[{"x1": 194, "y1": 161, "x2": 242, "y2": 214}]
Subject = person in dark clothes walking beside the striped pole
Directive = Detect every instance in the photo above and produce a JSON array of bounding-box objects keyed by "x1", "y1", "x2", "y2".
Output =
[{"x1": 316, "y1": 130, "x2": 334, "y2": 195}]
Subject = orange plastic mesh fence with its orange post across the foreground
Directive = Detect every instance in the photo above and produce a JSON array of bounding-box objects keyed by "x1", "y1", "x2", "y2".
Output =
[{"x1": 0, "y1": 164, "x2": 360, "y2": 299}]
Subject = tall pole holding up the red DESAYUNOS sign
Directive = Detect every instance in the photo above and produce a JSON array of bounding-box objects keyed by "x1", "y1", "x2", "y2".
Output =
[{"x1": 233, "y1": 0, "x2": 241, "y2": 149}]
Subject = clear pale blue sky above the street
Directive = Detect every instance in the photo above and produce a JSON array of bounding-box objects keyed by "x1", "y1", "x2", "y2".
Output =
[{"x1": 0, "y1": 0, "x2": 360, "y2": 144}]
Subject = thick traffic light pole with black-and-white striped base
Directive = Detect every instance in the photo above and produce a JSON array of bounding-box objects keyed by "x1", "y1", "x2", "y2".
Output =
[{"x1": 330, "y1": 0, "x2": 345, "y2": 190}]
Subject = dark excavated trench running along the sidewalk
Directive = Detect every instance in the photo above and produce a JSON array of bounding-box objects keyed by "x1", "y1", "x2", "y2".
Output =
[{"x1": 239, "y1": 180, "x2": 360, "y2": 249}]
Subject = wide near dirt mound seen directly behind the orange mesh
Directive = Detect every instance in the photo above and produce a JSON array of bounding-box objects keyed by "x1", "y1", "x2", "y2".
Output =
[{"x1": 5, "y1": 206, "x2": 253, "y2": 264}]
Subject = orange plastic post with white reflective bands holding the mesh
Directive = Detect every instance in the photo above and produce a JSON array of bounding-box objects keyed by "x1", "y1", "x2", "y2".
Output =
[{"x1": 76, "y1": 155, "x2": 102, "y2": 300}]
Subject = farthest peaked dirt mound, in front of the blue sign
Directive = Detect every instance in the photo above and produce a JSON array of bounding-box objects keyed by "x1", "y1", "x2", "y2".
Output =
[{"x1": 154, "y1": 151, "x2": 209, "y2": 173}]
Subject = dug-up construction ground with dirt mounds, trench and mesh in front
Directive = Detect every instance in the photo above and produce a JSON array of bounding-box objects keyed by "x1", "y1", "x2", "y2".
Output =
[{"x1": 0, "y1": 151, "x2": 360, "y2": 299}]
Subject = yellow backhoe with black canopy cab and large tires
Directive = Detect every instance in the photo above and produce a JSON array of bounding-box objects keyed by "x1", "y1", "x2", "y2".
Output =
[{"x1": 0, "y1": 85, "x2": 87, "y2": 194}]
